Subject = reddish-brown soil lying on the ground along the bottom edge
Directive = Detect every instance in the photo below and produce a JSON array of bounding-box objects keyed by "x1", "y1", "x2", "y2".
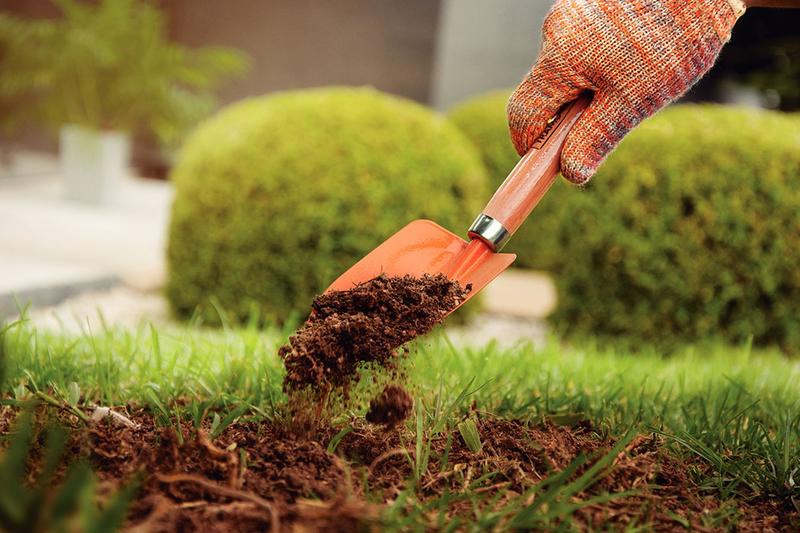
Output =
[{"x1": 4, "y1": 411, "x2": 800, "y2": 531}]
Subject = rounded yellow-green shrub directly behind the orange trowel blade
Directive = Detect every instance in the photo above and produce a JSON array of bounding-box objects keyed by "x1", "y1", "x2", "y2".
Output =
[{"x1": 167, "y1": 88, "x2": 486, "y2": 321}]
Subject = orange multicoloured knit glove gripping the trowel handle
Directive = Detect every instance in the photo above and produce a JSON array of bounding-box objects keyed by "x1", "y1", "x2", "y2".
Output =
[{"x1": 508, "y1": 0, "x2": 745, "y2": 184}]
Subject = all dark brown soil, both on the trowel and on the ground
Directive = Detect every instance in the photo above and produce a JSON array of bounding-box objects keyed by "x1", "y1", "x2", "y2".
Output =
[{"x1": 0, "y1": 276, "x2": 800, "y2": 532}]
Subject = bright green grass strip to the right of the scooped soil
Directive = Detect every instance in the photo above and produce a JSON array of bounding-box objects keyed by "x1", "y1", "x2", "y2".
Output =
[{"x1": 413, "y1": 339, "x2": 800, "y2": 499}]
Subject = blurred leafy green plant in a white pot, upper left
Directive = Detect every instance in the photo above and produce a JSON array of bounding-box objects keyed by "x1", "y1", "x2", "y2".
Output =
[{"x1": 0, "y1": 0, "x2": 247, "y2": 203}]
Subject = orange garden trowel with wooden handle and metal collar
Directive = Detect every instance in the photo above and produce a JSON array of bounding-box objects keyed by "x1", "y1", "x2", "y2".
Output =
[{"x1": 326, "y1": 95, "x2": 591, "y2": 314}]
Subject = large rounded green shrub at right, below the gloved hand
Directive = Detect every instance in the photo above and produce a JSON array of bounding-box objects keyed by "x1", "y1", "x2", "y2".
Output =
[{"x1": 553, "y1": 105, "x2": 800, "y2": 351}]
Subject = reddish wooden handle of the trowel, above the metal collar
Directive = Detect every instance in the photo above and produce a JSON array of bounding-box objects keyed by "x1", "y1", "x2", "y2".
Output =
[{"x1": 483, "y1": 94, "x2": 592, "y2": 234}]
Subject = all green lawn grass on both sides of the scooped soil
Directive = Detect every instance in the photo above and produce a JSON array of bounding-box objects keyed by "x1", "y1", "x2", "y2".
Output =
[{"x1": 3, "y1": 316, "x2": 800, "y2": 528}]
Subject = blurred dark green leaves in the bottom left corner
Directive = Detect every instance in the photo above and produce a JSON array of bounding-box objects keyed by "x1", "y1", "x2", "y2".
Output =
[{"x1": 0, "y1": 410, "x2": 137, "y2": 533}]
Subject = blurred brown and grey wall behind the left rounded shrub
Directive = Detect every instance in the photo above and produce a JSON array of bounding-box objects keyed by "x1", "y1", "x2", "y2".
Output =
[{"x1": 0, "y1": 0, "x2": 550, "y2": 107}]
